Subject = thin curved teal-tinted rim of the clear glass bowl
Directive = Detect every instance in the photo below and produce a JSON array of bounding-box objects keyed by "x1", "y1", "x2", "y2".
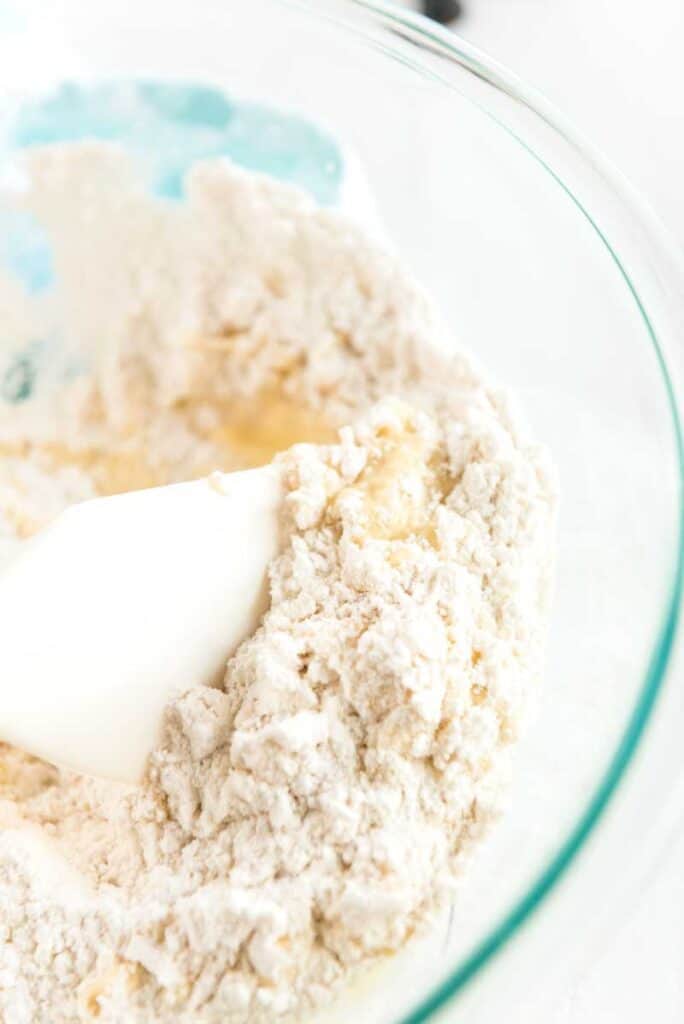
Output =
[{"x1": 285, "y1": 0, "x2": 684, "y2": 1024}]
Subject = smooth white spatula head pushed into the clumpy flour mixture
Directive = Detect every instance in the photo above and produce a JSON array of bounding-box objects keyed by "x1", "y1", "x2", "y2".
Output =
[{"x1": 0, "y1": 467, "x2": 281, "y2": 782}]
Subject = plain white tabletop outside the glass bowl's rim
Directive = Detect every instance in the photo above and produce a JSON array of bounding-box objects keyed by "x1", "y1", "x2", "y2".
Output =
[{"x1": 407, "y1": 0, "x2": 684, "y2": 1024}]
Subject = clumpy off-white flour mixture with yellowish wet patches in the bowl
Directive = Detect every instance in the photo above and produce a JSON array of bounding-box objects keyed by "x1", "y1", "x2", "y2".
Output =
[{"x1": 0, "y1": 143, "x2": 554, "y2": 1024}]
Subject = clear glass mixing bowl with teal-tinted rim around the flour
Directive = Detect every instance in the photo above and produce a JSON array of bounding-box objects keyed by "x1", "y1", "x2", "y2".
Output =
[{"x1": 0, "y1": 0, "x2": 684, "y2": 1024}]
